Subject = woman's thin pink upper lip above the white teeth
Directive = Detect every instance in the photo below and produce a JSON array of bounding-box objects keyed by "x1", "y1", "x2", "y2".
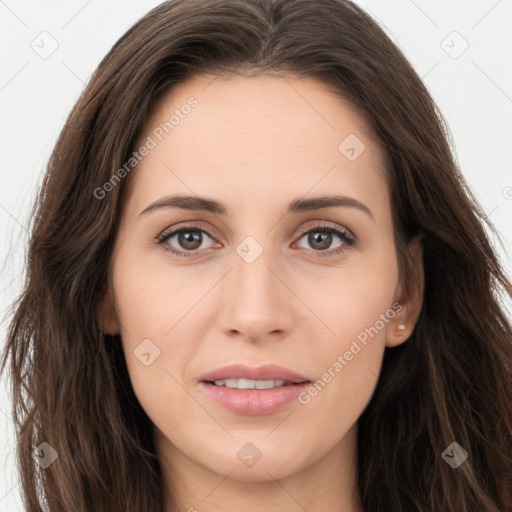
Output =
[{"x1": 199, "y1": 364, "x2": 310, "y2": 384}]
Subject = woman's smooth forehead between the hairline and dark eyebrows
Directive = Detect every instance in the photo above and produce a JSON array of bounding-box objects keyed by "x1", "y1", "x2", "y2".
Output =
[{"x1": 122, "y1": 75, "x2": 388, "y2": 220}]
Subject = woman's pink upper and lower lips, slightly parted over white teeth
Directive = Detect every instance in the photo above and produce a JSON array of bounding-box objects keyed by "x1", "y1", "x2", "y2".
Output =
[{"x1": 199, "y1": 364, "x2": 311, "y2": 416}]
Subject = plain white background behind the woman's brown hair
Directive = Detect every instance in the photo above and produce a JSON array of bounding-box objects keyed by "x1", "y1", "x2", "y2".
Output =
[{"x1": 0, "y1": 0, "x2": 512, "y2": 512}]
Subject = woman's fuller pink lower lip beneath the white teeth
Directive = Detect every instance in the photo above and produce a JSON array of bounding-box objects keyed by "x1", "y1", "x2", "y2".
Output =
[{"x1": 199, "y1": 381, "x2": 310, "y2": 416}]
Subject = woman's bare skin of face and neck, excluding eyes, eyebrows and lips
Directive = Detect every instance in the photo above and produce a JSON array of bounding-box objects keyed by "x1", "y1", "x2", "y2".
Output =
[{"x1": 102, "y1": 76, "x2": 423, "y2": 512}]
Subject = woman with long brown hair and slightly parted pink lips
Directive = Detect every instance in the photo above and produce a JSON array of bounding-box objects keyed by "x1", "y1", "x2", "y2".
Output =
[{"x1": 3, "y1": 0, "x2": 512, "y2": 512}]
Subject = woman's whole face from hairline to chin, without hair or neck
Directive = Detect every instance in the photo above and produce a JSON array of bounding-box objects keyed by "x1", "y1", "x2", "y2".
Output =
[{"x1": 100, "y1": 72, "x2": 420, "y2": 481}]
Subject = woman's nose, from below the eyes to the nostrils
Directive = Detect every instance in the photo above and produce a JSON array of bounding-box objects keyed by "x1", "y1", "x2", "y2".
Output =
[{"x1": 218, "y1": 243, "x2": 300, "y2": 343}]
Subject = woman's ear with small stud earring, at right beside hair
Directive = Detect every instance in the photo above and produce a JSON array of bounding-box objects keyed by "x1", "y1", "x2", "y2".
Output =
[{"x1": 386, "y1": 235, "x2": 425, "y2": 347}]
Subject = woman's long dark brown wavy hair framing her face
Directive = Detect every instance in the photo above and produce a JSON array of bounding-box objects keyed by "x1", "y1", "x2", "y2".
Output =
[{"x1": 2, "y1": 0, "x2": 512, "y2": 512}]
